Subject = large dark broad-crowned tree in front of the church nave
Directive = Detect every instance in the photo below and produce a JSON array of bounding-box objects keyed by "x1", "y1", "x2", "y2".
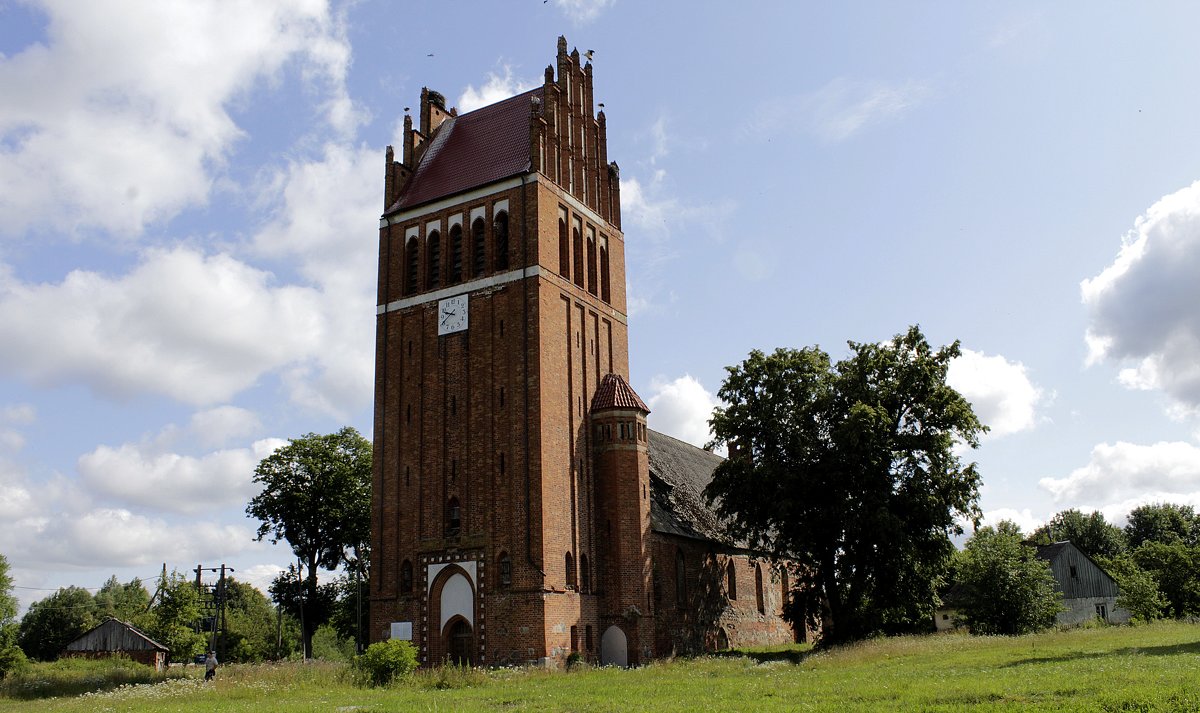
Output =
[{"x1": 706, "y1": 326, "x2": 986, "y2": 645}]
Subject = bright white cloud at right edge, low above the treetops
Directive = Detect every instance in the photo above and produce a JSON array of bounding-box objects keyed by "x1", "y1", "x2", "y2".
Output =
[{"x1": 1038, "y1": 442, "x2": 1200, "y2": 504}]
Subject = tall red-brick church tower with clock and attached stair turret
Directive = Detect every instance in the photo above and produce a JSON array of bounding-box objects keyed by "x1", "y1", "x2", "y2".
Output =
[{"x1": 371, "y1": 37, "x2": 654, "y2": 665}]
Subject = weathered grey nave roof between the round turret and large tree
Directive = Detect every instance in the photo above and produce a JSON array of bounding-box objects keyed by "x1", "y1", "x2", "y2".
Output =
[{"x1": 649, "y1": 430, "x2": 740, "y2": 546}]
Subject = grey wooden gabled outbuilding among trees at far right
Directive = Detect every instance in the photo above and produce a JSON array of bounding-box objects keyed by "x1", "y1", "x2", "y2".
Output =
[{"x1": 1038, "y1": 540, "x2": 1129, "y2": 625}]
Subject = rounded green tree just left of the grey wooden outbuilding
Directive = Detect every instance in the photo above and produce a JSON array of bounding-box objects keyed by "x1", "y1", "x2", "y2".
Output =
[{"x1": 955, "y1": 520, "x2": 1062, "y2": 635}]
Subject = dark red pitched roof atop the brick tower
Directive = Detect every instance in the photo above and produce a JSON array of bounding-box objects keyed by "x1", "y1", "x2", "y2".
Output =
[{"x1": 388, "y1": 86, "x2": 542, "y2": 212}]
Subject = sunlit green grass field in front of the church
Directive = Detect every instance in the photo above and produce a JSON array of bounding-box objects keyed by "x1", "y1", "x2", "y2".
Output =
[{"x1": 0, "y1": 622, "x2": 1200, "y2": 713}]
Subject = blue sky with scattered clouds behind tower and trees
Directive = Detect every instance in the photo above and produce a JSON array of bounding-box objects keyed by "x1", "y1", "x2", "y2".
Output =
[{"x1": 0, "y1": 0, "x2": 1200, "y2": 604}]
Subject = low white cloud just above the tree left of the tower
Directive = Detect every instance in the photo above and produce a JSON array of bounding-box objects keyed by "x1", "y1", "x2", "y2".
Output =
[{"x1": 78, "y1": 438, "x2": 287, "y2": 513}]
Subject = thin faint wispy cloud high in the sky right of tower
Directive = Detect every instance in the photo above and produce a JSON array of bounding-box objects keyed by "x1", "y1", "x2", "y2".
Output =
[{"x1": 740, "y1": 77, "x2": 934, "y2": 143}]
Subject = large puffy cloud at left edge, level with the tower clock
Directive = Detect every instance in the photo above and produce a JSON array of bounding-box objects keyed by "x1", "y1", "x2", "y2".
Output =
[{"x1": 0, "y1": 247, "x2": 329, "y2": 405}]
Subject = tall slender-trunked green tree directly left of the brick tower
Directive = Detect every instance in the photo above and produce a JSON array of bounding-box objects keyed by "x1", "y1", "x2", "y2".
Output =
[{"x1": 246, "y1": 427, "x2": 371, "y2": 658}]
